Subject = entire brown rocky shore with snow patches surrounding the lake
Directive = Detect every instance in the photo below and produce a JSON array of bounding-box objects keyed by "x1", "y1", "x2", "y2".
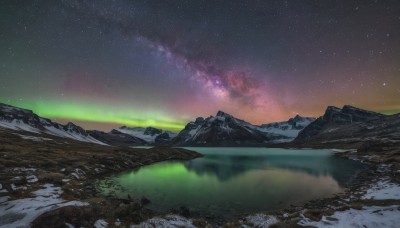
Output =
[{"x1": 0, "y1": 125, "x2": 400, "y2": 227}]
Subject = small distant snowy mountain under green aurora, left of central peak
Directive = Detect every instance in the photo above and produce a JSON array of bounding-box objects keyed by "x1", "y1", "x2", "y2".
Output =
[{"x1": 114, "y1": 126, "x2": 176, "y2": 144}]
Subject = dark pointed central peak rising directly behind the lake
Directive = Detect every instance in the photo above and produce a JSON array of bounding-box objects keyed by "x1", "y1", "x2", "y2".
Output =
[{"x1": 171, "y1": 111, "x2": 300, "y2": 146}]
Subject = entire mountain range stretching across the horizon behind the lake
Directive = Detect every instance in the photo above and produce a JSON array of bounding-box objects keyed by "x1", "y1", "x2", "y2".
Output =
[{"x1": 0, "y1": 103, "x2": 397, "y2": 146}]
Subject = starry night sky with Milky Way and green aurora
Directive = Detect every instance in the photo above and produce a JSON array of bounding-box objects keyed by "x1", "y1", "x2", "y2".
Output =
[{"x1": 0, "y1": 0, "x2": 400, "y2": 131}]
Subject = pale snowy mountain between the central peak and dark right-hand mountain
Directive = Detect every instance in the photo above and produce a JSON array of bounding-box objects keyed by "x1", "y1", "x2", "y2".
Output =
[{"x1": 258, "y1": 115, "x2": 316, "y2": 142}]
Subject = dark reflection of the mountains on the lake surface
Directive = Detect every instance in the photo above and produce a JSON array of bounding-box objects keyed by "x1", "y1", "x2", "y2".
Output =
[{"x1": 184, "y1": 155, "x2": 359, "y2": 185}]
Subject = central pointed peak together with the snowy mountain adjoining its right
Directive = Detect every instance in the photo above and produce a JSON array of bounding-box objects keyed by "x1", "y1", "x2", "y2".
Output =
[{"x1": 172, "y1": 111, "x2": 315, "y2": 146}]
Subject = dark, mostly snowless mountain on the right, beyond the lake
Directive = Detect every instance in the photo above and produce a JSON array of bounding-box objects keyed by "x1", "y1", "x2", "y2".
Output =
[{"x1": 295, "y1": 105, "x2": 384, "y2": 142}]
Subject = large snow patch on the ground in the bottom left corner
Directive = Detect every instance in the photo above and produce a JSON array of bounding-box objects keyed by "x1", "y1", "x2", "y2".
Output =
[{"x1": 0, "y1": 184, "x2": 88, "y2": 228}]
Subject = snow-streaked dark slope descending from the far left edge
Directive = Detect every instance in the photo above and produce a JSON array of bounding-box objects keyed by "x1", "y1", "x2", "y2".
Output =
[{"x1": 0, "y1": 103, "x2": 106, "y2": 145}]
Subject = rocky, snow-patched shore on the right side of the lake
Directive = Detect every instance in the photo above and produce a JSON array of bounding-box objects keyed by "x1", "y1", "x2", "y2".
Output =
[{"x1": 224, "y1": 141, "x2": 400, "y2": 227}]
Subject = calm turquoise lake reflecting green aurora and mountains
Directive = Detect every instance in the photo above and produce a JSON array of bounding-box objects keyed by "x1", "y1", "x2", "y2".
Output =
[{"x1": 97, "y1": 147, "x2": 360, "y2": 217}]
